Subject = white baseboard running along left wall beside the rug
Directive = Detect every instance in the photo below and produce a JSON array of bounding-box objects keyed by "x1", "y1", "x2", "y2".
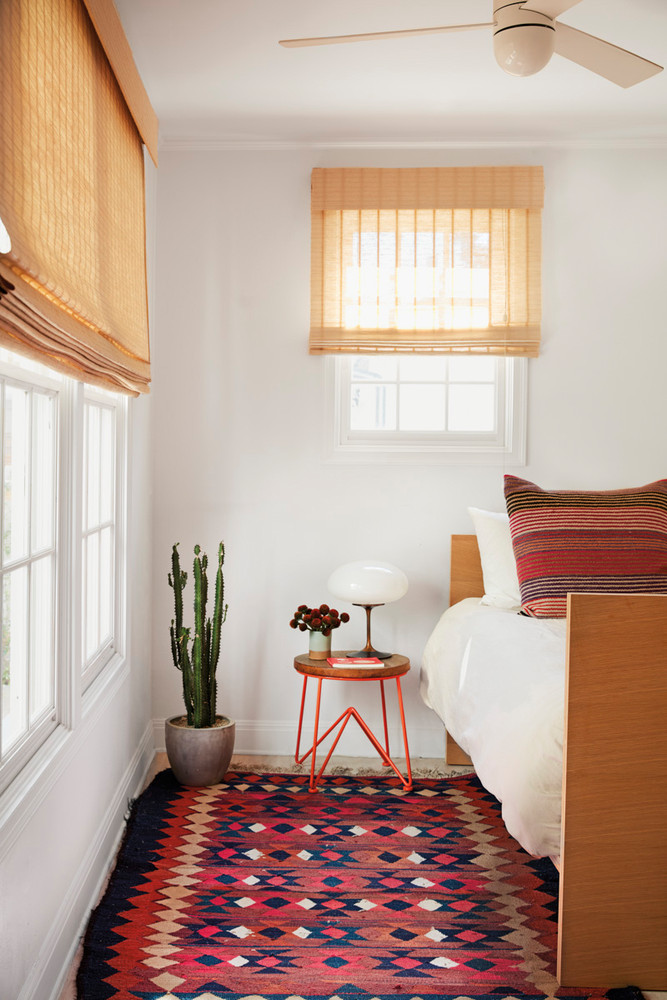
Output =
[{"x1": 18, "y1": 723, "x2": 155, "y2": 1000}]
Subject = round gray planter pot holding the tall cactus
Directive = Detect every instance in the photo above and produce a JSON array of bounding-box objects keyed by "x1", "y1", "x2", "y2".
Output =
[{"x1": 164, "y1": 715, "x2": 236, "y2": 786}]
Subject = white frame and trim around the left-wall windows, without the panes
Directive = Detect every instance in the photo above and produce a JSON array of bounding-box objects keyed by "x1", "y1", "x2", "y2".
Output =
[{"x1": 0, "y1": 357, "x2": 129, "y2": 796}]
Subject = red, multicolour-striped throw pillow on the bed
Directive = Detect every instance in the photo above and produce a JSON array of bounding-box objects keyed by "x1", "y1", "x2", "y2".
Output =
[{"x1": 505, "y1": 476, "x2": 667, "y2": 618}]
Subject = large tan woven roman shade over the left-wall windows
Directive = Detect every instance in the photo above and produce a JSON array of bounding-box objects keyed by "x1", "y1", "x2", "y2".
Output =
[{"x1": 0, "y1": 0, "x2": 157, "y2": 395}]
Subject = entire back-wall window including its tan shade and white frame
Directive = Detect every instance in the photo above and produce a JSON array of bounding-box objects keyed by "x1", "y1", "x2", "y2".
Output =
[{"x1": 310, "y1": 167, "x2": 544, "y2": 464}]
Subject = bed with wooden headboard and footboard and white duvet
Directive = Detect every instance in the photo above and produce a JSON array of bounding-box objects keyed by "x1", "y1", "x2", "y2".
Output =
[{"x1": 421, "y1": 480, "x2": 667, "y2": 990}]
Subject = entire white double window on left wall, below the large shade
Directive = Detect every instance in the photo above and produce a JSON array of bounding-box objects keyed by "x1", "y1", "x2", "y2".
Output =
[{"x1": 0, "y1": 350, "x2": 127, "y2": 789}]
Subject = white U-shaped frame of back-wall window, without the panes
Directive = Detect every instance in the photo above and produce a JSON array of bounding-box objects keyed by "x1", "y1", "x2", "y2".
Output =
[{"x1": 327, "y1": 354, "x2": 528, "y2": 466}]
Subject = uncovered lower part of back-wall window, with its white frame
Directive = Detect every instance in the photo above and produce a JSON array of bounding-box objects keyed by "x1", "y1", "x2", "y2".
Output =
[{"x1": 331, "y1": 354, "x2": 526, "y2": 465}]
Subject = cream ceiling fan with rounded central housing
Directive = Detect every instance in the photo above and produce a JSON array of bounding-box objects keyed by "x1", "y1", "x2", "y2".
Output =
[{"x1": 280, "y1": 0, "x2": 663, "y2": 87}]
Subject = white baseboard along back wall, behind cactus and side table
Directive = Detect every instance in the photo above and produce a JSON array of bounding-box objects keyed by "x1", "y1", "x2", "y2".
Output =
[{"x1": 153, "y1": 719, "x2": 445, "y2": 757}]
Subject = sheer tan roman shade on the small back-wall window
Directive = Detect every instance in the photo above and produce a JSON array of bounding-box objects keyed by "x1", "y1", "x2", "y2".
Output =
[{"x1": 310, "y1": 167, "x2": 544, "y2": 357}]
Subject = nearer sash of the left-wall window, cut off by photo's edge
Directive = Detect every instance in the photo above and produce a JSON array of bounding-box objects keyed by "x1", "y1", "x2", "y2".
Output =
[{"x1": 0, "y1": 360, "x2": 60, "y2": 780}]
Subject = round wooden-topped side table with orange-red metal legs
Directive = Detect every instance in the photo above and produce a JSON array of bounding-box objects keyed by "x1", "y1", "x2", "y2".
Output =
[{"x1": 294, "y1": 650, "x2": 412, "y2": 792}]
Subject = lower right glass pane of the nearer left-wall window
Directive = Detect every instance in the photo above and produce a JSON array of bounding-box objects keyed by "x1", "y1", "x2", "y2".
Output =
[{"x1": 30, "y1": 556, "x2": 55, "y2": 722}]
